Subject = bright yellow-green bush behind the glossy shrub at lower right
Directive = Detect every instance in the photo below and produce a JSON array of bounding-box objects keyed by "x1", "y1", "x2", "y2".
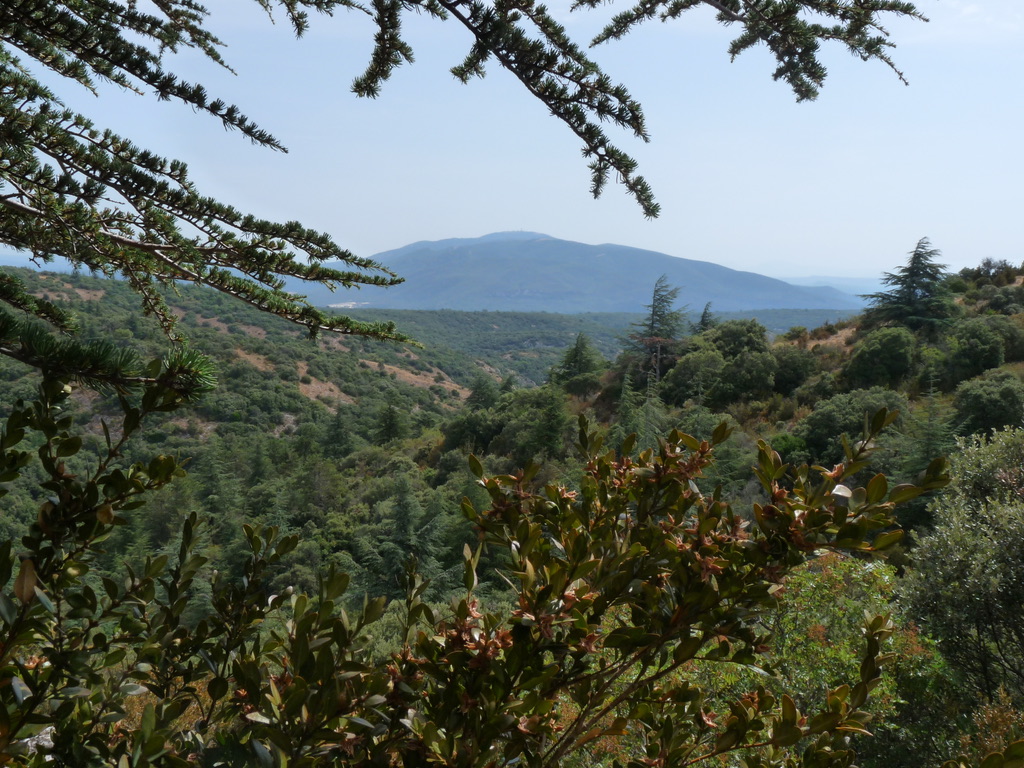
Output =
[{"x1": 698, "y1": 553, "x2": 955, "y2": 768}]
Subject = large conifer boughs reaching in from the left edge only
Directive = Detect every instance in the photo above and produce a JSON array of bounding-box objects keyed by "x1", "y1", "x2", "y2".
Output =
[{"x1": 0, "y1": 0, "x2": 399, "y2": 338}]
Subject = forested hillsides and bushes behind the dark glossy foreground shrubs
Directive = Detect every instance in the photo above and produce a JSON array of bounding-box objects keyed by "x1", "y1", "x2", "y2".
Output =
[{"x1": 2, "y1": 242, "x2": 1024, "y2": 767}]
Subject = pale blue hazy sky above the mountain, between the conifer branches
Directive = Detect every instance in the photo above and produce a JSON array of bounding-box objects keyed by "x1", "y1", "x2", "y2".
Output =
[{"x1": 34, "y1": 0, "x2": 1024, "y2": 278}]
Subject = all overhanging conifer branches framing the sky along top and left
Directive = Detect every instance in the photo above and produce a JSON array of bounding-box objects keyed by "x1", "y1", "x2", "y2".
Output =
[{"x1": 0, "y1": 0, "x2": 922, "y2": 370}]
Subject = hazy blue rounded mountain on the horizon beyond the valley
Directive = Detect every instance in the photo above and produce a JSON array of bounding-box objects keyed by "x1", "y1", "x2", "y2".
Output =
[{"x1": 307, "y1": 231, "x2": 862, "y2": 314}]
